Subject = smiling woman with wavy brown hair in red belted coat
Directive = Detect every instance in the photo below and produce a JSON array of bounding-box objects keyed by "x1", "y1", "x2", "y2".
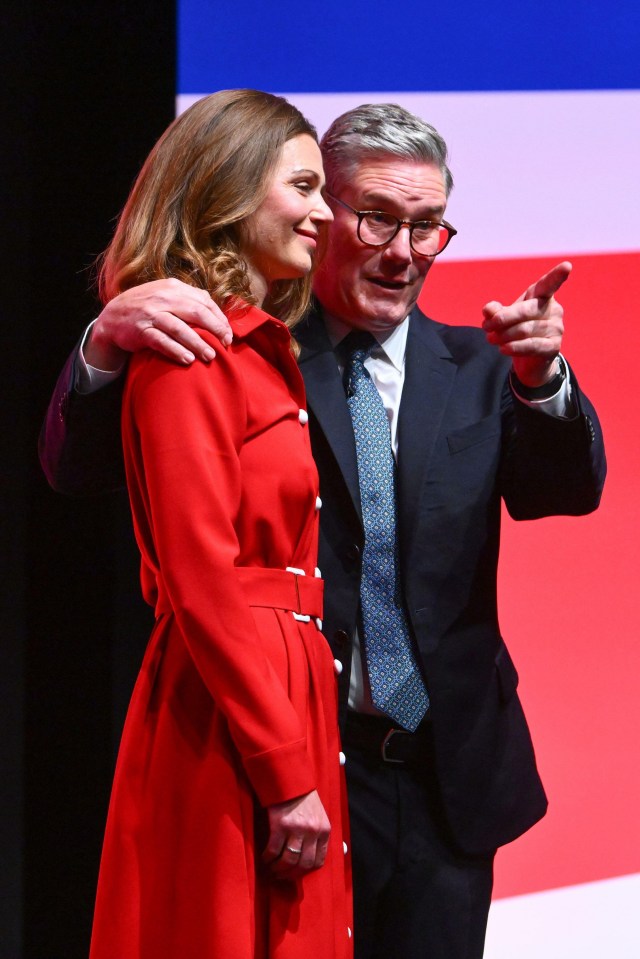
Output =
[{"x1": 86, "y1": 90, "x2": 351, "y2": 959}]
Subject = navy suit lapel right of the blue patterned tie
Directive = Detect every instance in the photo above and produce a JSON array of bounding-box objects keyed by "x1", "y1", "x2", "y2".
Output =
[{"x1": 398, "y1": 309, "x2": 456, "y2": 559}]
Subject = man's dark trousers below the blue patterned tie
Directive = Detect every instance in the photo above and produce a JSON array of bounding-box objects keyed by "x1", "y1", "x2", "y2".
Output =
[{"x1": 343, "y1": 714, "x2": 494, "y2": 959}]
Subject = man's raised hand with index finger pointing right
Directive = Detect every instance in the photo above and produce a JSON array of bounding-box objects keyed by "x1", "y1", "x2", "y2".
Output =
[{"x1": 482, "y1": 261, "x2": 571, "y2": 386}]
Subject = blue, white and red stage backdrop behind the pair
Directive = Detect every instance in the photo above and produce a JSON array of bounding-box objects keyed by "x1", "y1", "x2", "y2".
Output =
[{"x1": 177, "y1": 0, "x2": 640, "y2": 959}]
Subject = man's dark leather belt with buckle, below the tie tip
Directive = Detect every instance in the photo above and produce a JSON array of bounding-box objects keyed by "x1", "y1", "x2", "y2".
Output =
[{"x1": 343, "y1": 710, "x2": 432, "y2": 767}]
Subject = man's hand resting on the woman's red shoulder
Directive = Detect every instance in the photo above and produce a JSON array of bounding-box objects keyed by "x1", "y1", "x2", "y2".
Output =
[{"x1": 84, "y1": 279, "x2": 232, "y2": 370}]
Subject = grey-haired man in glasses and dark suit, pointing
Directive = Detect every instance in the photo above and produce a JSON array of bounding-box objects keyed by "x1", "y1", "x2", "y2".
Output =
[{"x1": 42, "y1": 104, "x2": 605, "y2": 959}]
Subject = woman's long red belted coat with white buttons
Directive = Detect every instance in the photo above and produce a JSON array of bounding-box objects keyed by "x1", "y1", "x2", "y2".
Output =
[{"x1": 91, "y1": 308, "x2": 351, "y2": 959}]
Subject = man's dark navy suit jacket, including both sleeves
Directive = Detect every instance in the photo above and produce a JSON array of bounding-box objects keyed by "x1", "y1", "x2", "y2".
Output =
[{"x1": 41, "y1": 309, "x2": 606, "y2": 853}]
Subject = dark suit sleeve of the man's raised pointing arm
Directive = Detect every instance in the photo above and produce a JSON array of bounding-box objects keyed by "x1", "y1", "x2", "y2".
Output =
[{"x1": 503, "y1": 364, "x2": 607, "y2": 519}]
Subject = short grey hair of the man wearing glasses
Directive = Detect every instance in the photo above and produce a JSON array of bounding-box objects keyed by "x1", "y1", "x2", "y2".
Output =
[{"x1": 320, "y1": 103, "x2": 453, "y2": 196}]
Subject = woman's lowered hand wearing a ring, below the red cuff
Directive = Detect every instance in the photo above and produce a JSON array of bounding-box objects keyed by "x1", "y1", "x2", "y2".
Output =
[{"x1": 262, "y1": 789, "x2": 331, "y2": 879}]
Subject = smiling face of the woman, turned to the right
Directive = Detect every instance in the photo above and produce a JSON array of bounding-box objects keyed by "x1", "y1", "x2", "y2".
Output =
[{"x1": 242, "y1": 133, "x2": 333, "y2": 302}]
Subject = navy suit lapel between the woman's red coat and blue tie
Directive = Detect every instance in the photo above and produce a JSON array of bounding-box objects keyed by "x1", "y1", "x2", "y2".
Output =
[{"x1": 295, "y1": 307, "x2": 360, "y2": 515}]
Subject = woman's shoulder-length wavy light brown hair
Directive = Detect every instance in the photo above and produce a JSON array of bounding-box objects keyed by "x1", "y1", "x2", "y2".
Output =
[{"x1": 98, "y1": 90, "x2": 317, "y2": 326}]
